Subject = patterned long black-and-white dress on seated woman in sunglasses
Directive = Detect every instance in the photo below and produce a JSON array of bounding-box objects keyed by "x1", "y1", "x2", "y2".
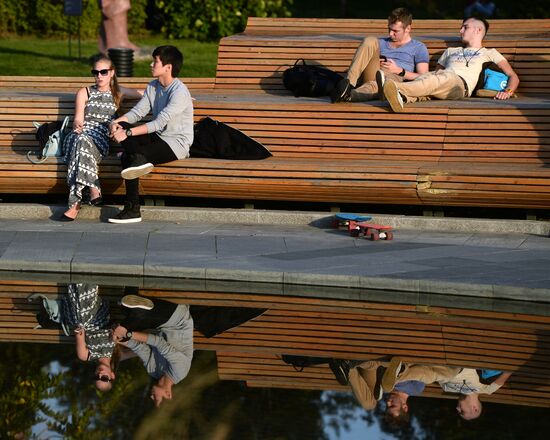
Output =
[{"x1": 63, "y1": 86, "x2": 116, "y2": 206}]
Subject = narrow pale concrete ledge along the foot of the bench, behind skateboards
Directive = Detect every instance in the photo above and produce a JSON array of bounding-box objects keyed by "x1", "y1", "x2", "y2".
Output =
[{"x1": 0, "y1": 203, "x2": 550, "y2": 236}]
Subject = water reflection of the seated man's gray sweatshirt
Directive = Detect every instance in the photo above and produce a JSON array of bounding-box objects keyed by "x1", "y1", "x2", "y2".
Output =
[{"x1": 128, "y1": 304, "x2": 193, "y2": 383}]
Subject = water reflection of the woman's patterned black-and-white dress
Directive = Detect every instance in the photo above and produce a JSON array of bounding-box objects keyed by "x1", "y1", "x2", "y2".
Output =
[{"x1": 61, "y1": 283, "x2": 115, "y2": 361}]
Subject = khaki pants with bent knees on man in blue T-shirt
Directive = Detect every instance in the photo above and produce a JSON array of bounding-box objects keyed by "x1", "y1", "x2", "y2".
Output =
[{"x1": 347, "y1": 37, "x2": 403, "y2": 99}]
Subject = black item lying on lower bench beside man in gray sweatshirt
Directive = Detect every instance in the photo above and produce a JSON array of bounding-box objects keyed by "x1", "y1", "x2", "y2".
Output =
[{"x1": 189, "y1": 116, "x2": 271, "y2": 160}]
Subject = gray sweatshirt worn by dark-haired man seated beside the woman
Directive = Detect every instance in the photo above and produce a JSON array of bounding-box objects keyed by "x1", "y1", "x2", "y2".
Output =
[{"x1": 124, "y1": 78, "x2": 193, "y2": 159}]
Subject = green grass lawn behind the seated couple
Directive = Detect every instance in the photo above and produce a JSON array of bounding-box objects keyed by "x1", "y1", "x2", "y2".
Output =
[{"x1": 0, "y1": 37, "x2": 218, "y2": 78}]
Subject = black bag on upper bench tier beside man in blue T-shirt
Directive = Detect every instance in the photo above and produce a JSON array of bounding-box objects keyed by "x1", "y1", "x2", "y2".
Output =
[{"x1": 283, "y1": 58, "x2": 343, "y2": 97}]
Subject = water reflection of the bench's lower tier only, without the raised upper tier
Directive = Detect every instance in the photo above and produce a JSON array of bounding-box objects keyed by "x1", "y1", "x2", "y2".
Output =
[{"x1": 4, "y1": 281, "x2": 550, "y2": 366}]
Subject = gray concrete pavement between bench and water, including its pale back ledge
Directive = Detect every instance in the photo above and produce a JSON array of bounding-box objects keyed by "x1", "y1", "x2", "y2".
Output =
[{"x1": 0, "y1": 204, "x2": 550, "y2": 302}]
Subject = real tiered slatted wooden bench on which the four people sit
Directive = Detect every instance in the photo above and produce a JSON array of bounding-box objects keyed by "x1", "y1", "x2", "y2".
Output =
[{"x1": 0, "y1": 18, "x2": 550, "y2": 208}]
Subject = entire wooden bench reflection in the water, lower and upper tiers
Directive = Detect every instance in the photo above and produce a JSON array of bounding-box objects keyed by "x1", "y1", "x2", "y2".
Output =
[{"x1": 0, "y1": 280, "x2": 550, "y2": 407}]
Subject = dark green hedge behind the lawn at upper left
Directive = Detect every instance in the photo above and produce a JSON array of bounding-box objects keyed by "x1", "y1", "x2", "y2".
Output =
[{"x1": 0, "y1": 0, "x2": 292, "y2": 40}]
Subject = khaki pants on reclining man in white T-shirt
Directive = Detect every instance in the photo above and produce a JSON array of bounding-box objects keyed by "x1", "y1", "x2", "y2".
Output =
[{"x1": 397, "y1": 69, "x2": 466, "y2": 102}]
